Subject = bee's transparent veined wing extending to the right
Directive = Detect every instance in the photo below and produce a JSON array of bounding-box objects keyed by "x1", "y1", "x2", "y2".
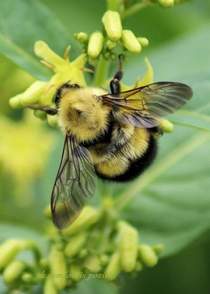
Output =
[{"x1": 102, "y1": 82, "x2": 192, "y2": 128}]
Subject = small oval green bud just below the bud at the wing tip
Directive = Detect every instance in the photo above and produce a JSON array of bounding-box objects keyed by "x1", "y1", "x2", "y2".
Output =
[{"x1": 65, "y1": 232, "x2": 87, "y2": 257}]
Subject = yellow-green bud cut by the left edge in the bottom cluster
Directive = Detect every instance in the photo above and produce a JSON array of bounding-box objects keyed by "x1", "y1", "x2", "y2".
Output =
[{"x1": 0, "y1": 240, "x2": 22, "y2": 270}]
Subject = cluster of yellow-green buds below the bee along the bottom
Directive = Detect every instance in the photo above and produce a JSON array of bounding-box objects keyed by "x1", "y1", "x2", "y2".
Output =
[{"x1": 0, "y1": 203, "x2": 163, "y2": 294}]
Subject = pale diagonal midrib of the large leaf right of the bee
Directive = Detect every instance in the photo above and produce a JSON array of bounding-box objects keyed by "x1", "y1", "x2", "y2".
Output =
[{"x1": 115, "y1": 133, "x2": 210, "y2": 210}]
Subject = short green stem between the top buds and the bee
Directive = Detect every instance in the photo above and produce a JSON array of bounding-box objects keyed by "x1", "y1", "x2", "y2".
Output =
[{"x1": 93, "y1": 56, "x2": 109, "y2": 87}]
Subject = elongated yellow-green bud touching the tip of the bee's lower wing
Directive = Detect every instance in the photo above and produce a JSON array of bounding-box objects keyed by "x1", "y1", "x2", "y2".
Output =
[{"x1": 62, "y1": 206, "x2": 100, "y2": 236}]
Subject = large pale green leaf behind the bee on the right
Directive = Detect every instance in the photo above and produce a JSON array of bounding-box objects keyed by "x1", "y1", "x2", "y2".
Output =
[{"x1": 116, "y1": 26, "x2": 210, "y2": 256}]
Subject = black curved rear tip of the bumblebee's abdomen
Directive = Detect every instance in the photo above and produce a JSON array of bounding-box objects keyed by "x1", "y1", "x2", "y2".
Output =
[{"x1": 96, "y1": 135, "x2": 158, "y2": 182}]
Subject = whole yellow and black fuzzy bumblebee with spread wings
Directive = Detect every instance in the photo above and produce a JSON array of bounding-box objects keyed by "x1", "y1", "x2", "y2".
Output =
[{"x1": 30, "y1": 65, "x2": 192, "y2": 228}]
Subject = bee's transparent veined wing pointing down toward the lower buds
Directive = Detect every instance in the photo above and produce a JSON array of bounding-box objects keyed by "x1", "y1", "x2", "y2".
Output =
[{"x1": 51, "y1": 136, "x2": 95, "y2": 228}]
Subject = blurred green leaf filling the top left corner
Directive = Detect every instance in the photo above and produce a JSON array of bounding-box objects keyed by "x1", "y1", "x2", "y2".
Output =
[{"x1": 0, "y1": 0, "x2": 79, "y2": 79}]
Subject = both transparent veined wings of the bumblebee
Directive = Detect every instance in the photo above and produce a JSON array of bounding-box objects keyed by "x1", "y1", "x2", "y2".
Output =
[{"x1": 51, "y1": 82, "x2": 192, "y2": 229}]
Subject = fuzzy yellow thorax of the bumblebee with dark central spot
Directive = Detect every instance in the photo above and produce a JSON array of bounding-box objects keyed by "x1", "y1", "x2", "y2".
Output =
[{"x1": 59, "y1": 88, "x2": 109, "y2": 141}]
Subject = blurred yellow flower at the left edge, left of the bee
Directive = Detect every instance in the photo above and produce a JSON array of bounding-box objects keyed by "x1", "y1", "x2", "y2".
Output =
[{"x1": 0, "y1": 111, "x2": 54, "y2": 203}]
